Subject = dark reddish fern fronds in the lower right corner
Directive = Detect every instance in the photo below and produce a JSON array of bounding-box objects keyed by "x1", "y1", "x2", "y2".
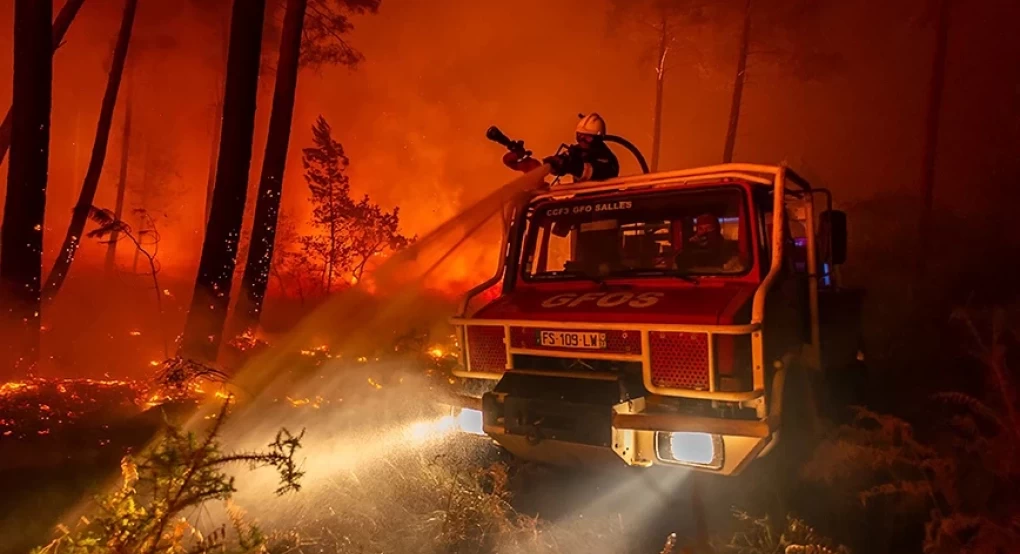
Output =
[{"x1": 805, "y1": 306, "x2": 1020, "y2": 554}]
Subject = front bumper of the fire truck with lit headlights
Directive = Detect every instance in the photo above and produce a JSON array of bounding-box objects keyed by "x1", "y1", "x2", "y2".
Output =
[{"x1": 444, "y1": 377, "x2": 778, "y2": 475}]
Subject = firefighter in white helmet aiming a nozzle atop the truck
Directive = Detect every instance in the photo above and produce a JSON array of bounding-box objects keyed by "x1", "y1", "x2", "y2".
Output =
[{"x1": 503, "y1": 113, "x2": 620, "y2": 183}]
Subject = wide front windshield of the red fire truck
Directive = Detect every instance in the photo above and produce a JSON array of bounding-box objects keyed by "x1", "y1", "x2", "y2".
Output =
[{"x1": 524, "y1": 187, "x2": 752, "y2": 281}]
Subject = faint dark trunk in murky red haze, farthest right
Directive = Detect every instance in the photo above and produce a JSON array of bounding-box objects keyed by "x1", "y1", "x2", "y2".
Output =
[{"x1": 916, "y1": 0, "x2": 950, "y2": 278}]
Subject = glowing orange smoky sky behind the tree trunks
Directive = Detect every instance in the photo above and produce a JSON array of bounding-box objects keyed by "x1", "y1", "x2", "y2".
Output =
[{"x1": 0, "y1": 0, "x2": 1020, "y2": 285}]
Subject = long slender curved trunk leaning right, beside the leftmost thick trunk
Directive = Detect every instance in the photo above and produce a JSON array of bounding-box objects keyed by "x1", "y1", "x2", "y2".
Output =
[{"x1": 43, "y1": 0, "x2": 138, "y2": 300}]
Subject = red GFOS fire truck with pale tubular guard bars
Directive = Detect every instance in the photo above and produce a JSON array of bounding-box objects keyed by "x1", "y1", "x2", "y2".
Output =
[{"x1": 452, "y1": 164, "x2": 860, "y2": 474}]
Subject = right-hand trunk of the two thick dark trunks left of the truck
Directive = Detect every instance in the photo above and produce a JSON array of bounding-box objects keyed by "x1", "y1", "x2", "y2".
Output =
[{"x1": 235, "y1": 0, "x2": 307, "y2": 329}]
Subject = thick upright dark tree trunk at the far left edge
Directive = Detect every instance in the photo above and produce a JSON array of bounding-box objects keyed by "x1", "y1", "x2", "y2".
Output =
[{"x1": 0, "y1": 0, "x2": 53, "y2": 376}]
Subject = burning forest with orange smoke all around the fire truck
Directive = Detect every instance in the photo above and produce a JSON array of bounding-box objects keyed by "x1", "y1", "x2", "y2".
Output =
[{"x1": 0, "y1": 0, "x2": 1020, "y2": 554}]
